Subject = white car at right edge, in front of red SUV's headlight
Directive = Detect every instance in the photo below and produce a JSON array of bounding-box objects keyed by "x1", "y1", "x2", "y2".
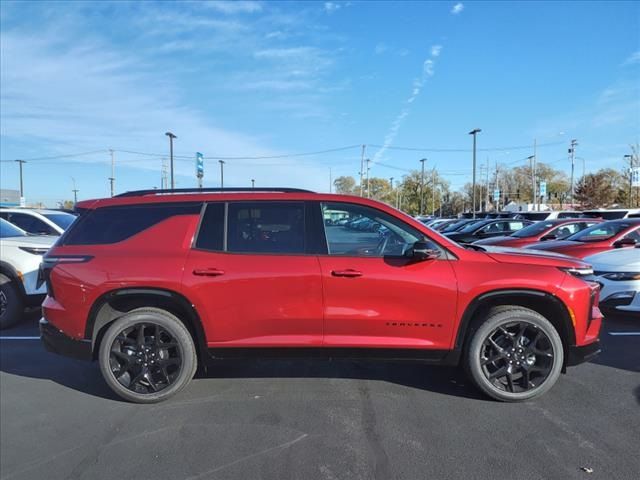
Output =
[{"x1": 584, "y1": 245, "x2": 640, "y2": 319}]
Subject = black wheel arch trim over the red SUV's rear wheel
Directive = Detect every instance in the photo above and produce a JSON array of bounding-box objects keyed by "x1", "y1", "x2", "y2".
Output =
[{"x1": 84, "y1": 287, "x2": 207, "y2": 365}]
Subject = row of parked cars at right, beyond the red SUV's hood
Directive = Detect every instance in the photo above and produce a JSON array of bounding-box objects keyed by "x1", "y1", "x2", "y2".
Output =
[{"x1": 423, "y1": 210, "x2": 640, "y2": 318}]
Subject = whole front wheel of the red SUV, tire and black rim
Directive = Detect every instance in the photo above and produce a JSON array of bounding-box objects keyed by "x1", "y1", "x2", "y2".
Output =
[{"x1": 465, "y1": 306, "x2": 564, "y2": 402}]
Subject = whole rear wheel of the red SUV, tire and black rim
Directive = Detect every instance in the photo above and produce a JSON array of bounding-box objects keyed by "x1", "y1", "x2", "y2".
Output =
[{"x1": 98, "y1": 307, "x2": 198, "y2": 403}]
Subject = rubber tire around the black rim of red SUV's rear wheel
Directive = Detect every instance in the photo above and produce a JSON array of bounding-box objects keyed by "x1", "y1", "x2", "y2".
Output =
[{"x1": 98, "y1": 308, "x2": 197, "y2": 403}]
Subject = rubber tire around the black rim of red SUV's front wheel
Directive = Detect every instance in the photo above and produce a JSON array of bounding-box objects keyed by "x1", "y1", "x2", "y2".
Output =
[{"x1": 466, "y1": 308, "x2": 564, "y2": 402}]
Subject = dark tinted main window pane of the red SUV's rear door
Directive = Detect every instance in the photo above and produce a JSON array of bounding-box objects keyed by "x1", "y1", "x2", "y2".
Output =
[{"x1": 227, "y1": 202, "x2": 305, "y2": 254}]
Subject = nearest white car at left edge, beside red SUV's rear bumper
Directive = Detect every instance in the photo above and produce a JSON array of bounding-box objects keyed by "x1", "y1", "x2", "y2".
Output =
[{"x1": 0, "y1": 218, "x2": 58, "y2": 329}]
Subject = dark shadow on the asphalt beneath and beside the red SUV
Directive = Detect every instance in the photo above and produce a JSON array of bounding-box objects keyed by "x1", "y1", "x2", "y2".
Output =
[{"x1": 0, "y1": 319, "x2": 640, "y2": 402}]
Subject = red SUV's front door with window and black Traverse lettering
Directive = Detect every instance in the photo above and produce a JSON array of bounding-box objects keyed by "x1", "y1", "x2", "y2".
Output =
[{"x1": 319, "y1": 203, "x2": 457, "y2": 350}]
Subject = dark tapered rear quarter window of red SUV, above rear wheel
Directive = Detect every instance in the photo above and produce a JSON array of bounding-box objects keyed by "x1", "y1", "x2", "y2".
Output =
[{"x1": 62, "y1": 203, "x2": 202, "y2": 245}]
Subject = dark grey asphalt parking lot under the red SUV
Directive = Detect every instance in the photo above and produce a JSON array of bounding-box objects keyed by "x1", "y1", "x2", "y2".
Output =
[{"x1": 0, "y1": 312, "x2": 640, "y2": 480}]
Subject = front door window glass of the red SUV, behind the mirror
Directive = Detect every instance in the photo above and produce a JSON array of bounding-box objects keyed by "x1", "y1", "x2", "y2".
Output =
[{"x1": 322, "y1": 203, "x2": 422, "y2": 257}]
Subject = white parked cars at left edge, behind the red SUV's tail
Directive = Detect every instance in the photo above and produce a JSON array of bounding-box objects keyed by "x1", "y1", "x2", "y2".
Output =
[{"x1": 0, "y1": 208, "x2": 76, "y2": 329}]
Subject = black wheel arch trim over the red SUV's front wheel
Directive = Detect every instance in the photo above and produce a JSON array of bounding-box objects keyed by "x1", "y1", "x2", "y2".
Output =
[{"x1": 453, "y1": 289, "x2": 576, "y2": 364}]
